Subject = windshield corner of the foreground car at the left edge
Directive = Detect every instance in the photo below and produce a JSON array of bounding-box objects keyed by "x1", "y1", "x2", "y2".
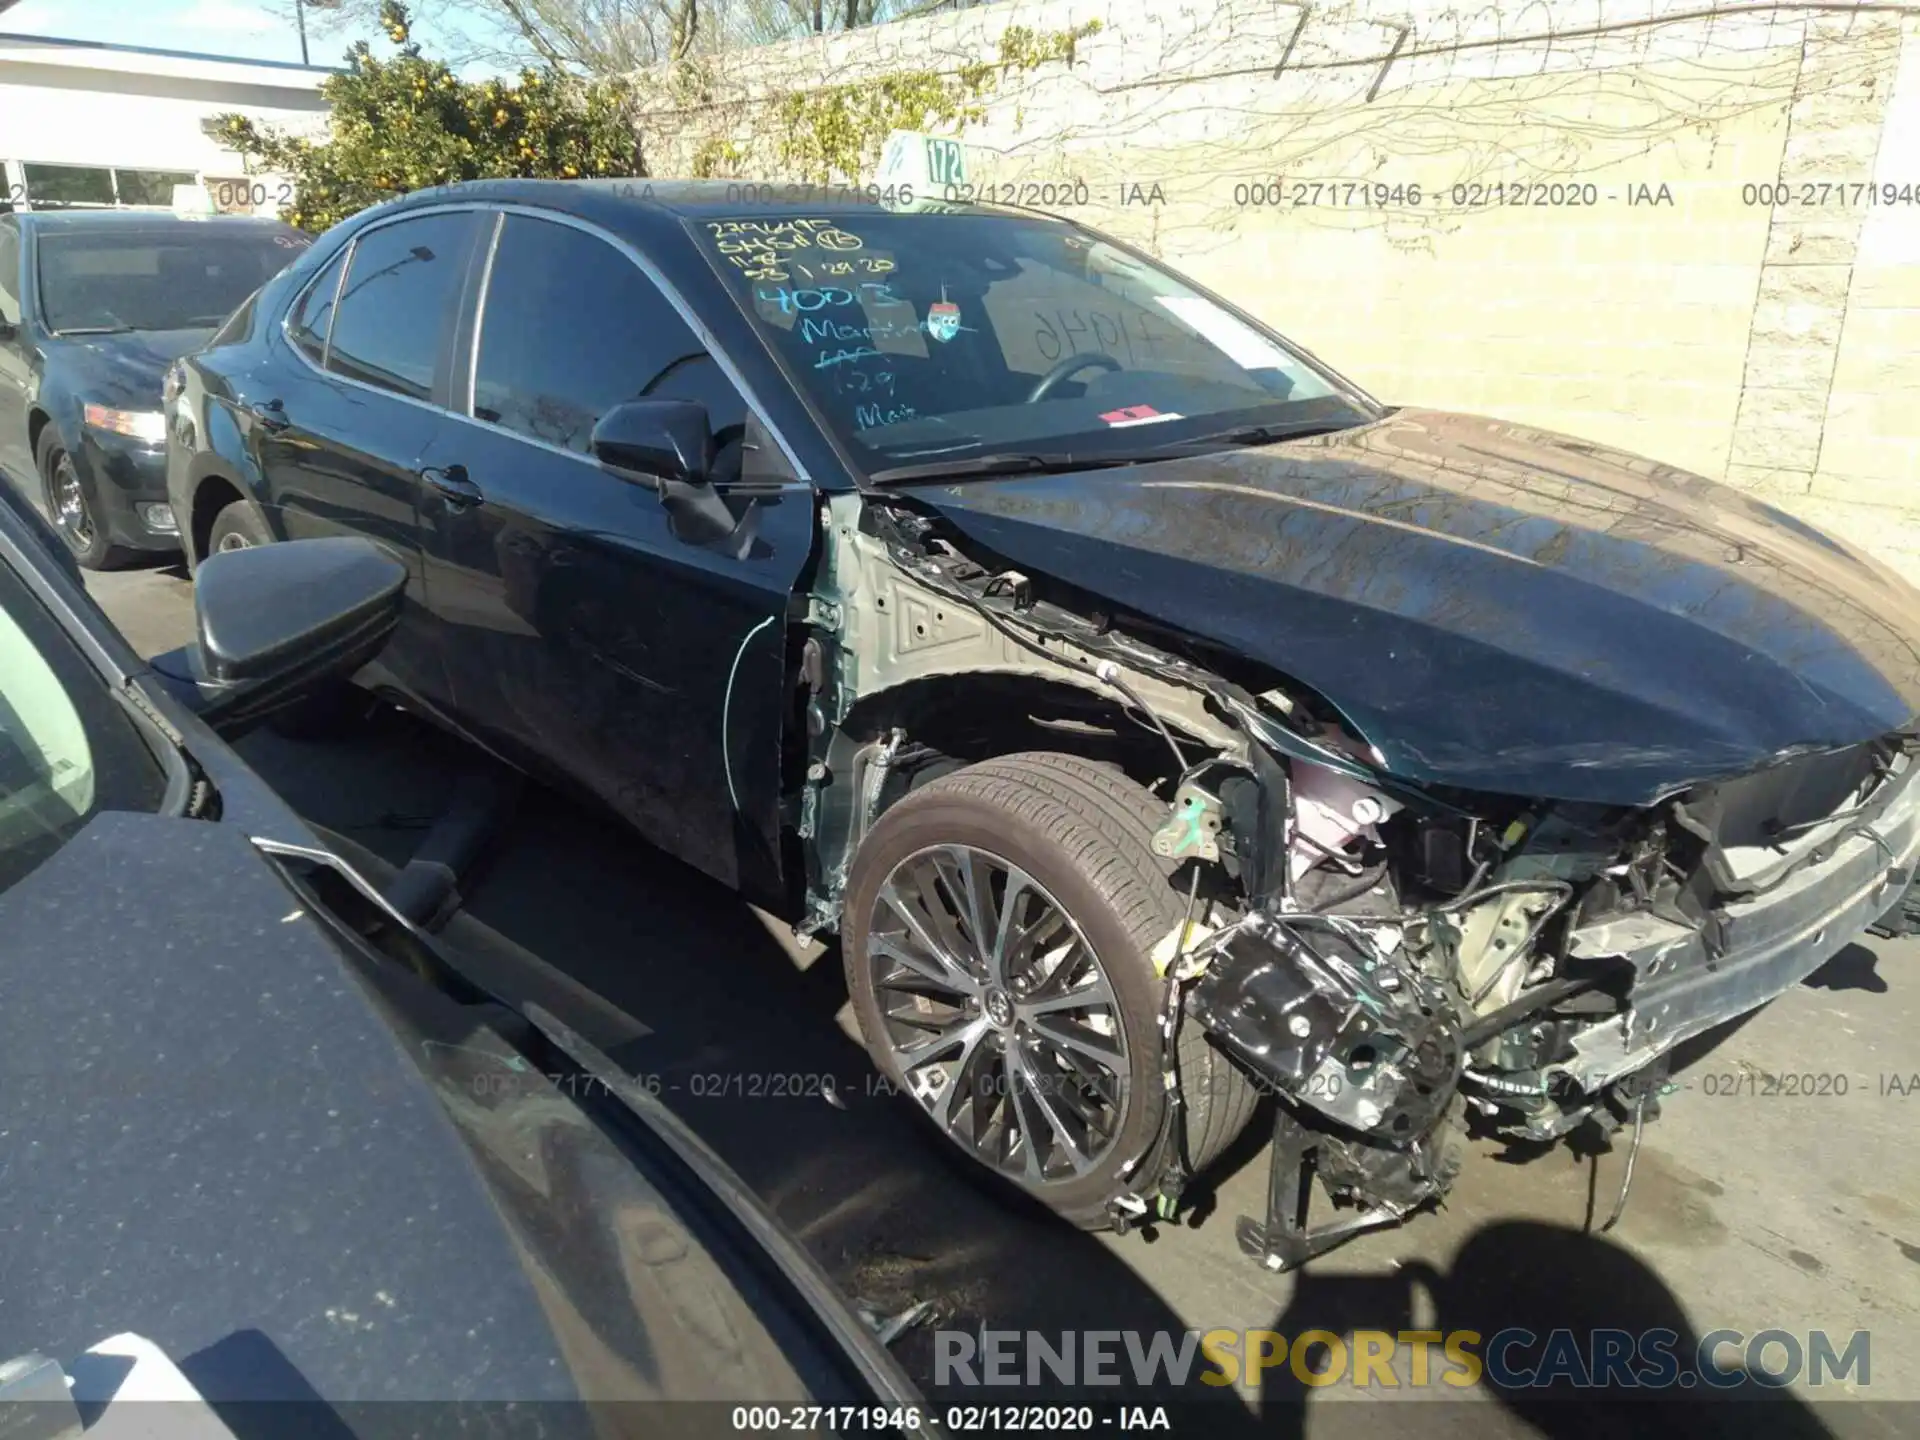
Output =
[{"x1": 0, "y1": 564, "x2": 165, "y2": 891}]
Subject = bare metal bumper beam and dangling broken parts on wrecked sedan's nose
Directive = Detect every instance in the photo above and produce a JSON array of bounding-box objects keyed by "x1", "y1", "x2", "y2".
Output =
[{"x1": 1190, "y1": 755, "x2": 1920, "y2": 1271}]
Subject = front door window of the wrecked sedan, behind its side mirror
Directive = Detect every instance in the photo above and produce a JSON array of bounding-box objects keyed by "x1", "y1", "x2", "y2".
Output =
[{"x1": 474, "y1": 215, "x2": 747, "y2": 465}]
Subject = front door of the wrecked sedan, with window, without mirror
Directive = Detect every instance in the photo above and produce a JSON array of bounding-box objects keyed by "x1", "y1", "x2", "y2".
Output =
[{"x1": 422, "y1": 211, "x2": 814, "y2": 902}]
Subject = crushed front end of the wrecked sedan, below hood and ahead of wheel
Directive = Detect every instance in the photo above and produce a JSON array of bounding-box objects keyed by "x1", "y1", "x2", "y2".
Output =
[{"x1": 1160, "y1": 728, "x2": 1920, "y2": 1269}]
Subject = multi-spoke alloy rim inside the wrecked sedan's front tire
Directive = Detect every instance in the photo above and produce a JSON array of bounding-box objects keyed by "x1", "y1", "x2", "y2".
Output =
[{"x1": 866, "y1": 845, "x2": 1131, "y2": 1187}]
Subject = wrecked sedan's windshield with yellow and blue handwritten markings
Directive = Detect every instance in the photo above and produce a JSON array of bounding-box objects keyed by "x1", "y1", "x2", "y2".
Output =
[{"x1": 689, "y1": 211, "x2": 1377, "y2": 470}]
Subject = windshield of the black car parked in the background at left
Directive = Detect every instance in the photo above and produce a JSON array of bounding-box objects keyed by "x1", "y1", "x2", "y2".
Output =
[{"x1": 35, "y1": 225, "x2": 311, "y2": 332}]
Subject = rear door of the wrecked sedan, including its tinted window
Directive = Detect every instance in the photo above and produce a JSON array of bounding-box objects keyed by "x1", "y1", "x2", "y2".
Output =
[{"x1": 259, "y1": 209, "x2": 478, "y2": 710}]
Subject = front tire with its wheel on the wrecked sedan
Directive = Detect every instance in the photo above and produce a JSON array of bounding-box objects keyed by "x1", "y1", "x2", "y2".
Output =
[{"x1": 841, "y1": 753, "x2": 1258, "y2": 1229}]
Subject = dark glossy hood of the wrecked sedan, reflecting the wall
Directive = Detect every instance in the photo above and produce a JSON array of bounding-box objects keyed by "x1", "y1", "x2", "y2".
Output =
[{"x1": 916, "y1": 409, "x2": 1920, "y2": 804}]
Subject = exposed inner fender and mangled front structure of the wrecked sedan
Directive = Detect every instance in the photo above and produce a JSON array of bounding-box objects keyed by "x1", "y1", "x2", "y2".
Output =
[{"x1": 797, "y1": 497, "x2": 1920, "y2": 1269}]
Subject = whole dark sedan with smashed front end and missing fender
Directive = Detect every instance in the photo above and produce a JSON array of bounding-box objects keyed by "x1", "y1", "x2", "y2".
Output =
[{"x1": 169, "y1": 180, "x2": 1920, "y2": 1267}]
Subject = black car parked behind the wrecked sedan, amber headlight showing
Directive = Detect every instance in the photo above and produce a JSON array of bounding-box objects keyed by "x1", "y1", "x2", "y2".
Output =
[{"x1": 0, "y1": 211, "x2": 311, "y2": 570}]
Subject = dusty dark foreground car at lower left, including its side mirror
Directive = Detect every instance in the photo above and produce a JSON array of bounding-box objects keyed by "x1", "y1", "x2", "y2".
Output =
[{"x1": 0, "y1": 481, "x2": 933, "y2": 1436}]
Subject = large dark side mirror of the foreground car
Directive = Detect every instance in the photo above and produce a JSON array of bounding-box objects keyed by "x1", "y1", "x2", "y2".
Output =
[{"x1": 154, "y1": 538, "x2": 407, "y2": 735}]
